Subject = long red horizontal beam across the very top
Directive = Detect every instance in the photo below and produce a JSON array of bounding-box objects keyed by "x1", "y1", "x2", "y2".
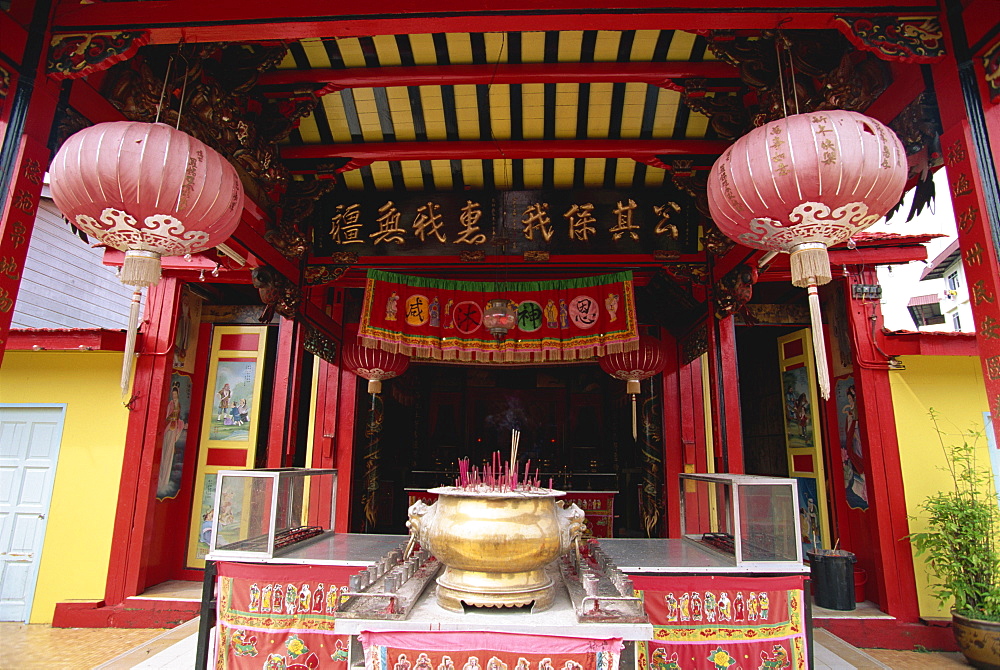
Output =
[{"x1": 54, "y1": 0, "x2": 937, "y2": 44}]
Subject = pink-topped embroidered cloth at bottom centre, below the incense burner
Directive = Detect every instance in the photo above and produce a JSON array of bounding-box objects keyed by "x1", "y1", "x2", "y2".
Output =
[{"x1": 361, "y1": 631, "x2": 622, "y2": 670}]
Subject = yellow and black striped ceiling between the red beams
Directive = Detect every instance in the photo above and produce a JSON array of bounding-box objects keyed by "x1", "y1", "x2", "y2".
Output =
[{"x1": 260, "y1": 30, "x2": 739, "y2": 191}]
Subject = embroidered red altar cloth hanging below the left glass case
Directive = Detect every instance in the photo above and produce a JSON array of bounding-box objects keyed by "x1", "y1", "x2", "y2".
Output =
[{"x1": 216, "y1": 563, "x2": 357, "y2": 670}]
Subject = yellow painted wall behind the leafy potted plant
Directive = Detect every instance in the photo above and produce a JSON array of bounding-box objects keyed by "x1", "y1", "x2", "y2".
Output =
[{"x1": 889, "y1": 356, "x2": 990, "y2": 618}]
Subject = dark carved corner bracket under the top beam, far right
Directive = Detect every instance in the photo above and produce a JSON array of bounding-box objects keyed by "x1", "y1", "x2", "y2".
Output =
[{"x1": 834, "y1": 16, "x2": 945, "y2": 63}]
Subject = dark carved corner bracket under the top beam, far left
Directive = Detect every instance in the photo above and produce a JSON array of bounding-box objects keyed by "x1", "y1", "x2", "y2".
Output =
[{"x1": 45, "y1": 30, "x2": 150, "y2": 79}]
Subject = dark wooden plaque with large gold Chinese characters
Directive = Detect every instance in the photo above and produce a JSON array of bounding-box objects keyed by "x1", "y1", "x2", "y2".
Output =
[{"x1": 313, "y1": 191, "x2": 698, "y2": 257}]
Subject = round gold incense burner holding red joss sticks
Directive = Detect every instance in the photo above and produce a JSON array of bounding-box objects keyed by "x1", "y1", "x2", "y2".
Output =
[{"x1": 407, "y1": 486, "x2": 584, "y2": 612}]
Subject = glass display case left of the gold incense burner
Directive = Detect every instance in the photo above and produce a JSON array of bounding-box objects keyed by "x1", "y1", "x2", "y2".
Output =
[{"x1": 208, "y1": 468, "x2": 337, "y2": 560}]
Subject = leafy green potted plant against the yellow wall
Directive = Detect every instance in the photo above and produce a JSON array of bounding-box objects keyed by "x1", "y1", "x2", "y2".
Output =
[{"x1": 910, "y1": 410, "x2": 1000, "y2": 670}]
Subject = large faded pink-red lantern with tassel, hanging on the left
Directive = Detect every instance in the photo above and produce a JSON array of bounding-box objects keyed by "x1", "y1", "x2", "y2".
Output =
[{"x1": 49, "y1": 121, "x2": 243, "y2": 393}]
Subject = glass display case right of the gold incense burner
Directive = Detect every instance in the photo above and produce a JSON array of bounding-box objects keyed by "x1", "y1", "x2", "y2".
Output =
[{"x1": 680, "y1": 474, "x2": 802, "y2": 570}]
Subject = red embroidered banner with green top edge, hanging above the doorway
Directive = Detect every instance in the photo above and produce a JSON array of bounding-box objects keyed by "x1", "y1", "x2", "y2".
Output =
[{"x1": 358, "y1": 270, "x2": 639, "y2": 363}]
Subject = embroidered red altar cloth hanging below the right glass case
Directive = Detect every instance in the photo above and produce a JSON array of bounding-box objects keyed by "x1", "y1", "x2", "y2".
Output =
[{"x1": 632, "y1": 575, "x2": 807, "y2": 670}]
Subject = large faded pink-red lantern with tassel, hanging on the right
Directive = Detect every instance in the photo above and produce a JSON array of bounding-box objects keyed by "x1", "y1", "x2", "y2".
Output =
[{"x1": 708, "y1": 110, "x2": 907, "y2": 399}]
